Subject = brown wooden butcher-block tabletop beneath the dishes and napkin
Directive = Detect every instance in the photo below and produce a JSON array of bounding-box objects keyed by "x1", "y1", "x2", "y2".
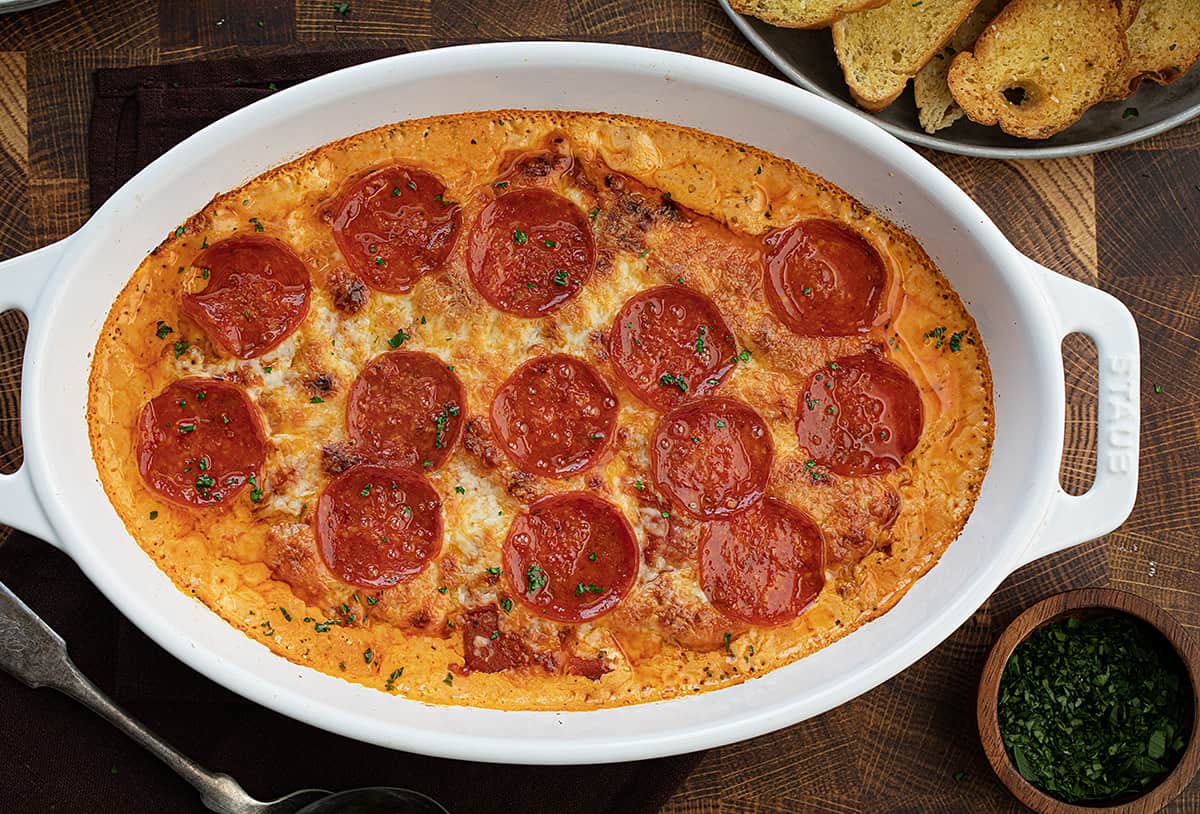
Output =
[{"x1": 0, "y1": 0, "x2": 1200, "y2": 814}]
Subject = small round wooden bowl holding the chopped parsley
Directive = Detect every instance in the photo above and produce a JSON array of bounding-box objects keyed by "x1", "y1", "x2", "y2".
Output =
[{"x1": 976, "y1": 588, "x2": 1200, "y2": 814}]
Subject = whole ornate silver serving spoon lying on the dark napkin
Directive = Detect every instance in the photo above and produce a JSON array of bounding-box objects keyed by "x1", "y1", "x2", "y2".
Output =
[{"x1": 0, "y1": 582, "x2": 449, "y2": 814}]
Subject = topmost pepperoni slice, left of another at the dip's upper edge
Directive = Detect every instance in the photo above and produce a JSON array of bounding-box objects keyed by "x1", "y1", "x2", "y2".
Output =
[{"x1": 334, "y1": 166, "x2": 462, "y2": 294}]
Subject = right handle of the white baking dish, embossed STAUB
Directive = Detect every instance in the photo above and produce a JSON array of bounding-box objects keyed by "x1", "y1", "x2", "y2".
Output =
[{"x1": 1021, "y1": 261, "x2": 1141, "y2": 564}]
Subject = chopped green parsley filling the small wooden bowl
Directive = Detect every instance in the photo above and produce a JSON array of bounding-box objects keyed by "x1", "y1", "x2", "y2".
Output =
[{"x1": 997, "y1": 616, "x2": 1186, "y2": 803}]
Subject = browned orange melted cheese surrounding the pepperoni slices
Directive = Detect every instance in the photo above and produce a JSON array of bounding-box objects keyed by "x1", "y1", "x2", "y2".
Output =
[{"x1": 89, "y1": 110, "x2": 994, "y2": 710}]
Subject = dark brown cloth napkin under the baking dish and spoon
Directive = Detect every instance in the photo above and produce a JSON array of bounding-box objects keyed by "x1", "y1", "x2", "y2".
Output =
[{"x1": 0, "y1": 50, "x2": 700, "y2": 814}]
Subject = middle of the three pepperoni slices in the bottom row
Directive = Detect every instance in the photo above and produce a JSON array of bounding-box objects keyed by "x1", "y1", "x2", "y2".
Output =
[{"x1": 503, "y1": 492, "x2": 640, "y2": 622}]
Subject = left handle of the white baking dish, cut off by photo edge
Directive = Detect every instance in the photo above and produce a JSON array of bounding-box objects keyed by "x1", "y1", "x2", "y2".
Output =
[{"x1": 0, "y1": 240, "x2": 67, "y2": 547}]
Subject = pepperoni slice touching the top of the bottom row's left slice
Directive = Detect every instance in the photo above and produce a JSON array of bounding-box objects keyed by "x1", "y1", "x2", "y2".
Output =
[{"x1": 346, "y1": 351, "x2": 467, "y2": 469}]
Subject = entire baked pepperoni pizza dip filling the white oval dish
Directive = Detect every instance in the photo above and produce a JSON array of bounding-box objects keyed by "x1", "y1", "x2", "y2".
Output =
[{"x1": 89, "y1": 112, "x2": 992, "y2": 710}]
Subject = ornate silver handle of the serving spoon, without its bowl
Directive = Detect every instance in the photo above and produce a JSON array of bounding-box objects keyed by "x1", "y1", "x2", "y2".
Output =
[{"x1": 0, "y1": 582, "x2": 265, "y2": 814}]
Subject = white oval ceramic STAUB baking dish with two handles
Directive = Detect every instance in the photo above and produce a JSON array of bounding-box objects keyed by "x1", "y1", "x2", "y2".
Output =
[{"x1": 0, "y1": 43, "x2": 1139, "y2": 764}]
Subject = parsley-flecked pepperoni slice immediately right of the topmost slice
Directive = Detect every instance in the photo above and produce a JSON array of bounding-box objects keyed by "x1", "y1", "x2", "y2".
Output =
[{"x1": 467, "y1": 190, "x2": 595, "y2": 317}]
